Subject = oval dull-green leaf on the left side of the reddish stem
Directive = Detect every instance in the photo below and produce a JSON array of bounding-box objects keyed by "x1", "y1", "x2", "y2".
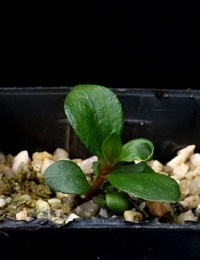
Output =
[{"x1": 44, "y1": 160, "x2": 90, "y2": 195}]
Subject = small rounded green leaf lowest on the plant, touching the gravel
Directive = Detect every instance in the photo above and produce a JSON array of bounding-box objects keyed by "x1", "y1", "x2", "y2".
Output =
[{"x1": 106, "y1": 192, "x2": 130, "y2": 213}]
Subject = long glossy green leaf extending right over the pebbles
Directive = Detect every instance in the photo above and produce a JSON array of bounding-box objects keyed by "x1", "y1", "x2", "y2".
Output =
[{"x1": 108, "y1": 172, "x2": 181, "y2": 202}]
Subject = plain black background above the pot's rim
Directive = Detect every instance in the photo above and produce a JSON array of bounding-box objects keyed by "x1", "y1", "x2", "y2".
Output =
[{"x1": 0, "y1": 0, "x2": 200, "y2": 89}]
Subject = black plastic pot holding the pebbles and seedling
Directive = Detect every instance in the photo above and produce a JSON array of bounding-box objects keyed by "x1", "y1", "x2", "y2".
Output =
[{"x1": 0, "y1": 87, "x2": 200, "y2": 260}]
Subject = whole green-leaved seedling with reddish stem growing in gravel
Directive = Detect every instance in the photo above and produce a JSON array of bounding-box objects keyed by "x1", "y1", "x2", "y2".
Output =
[{"x1": 44, "y1": 84, "x2": 180, "y2": 212}]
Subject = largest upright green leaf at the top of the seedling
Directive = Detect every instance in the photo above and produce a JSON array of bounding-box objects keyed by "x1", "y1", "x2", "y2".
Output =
[{"x1": 64, "y1": 84, "x2": 124, "y2": 158}]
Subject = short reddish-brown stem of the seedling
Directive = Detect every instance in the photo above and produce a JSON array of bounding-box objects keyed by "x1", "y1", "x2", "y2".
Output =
[{"x1": 85, "y1": 166, "x2": 112, "y2": 201}]
